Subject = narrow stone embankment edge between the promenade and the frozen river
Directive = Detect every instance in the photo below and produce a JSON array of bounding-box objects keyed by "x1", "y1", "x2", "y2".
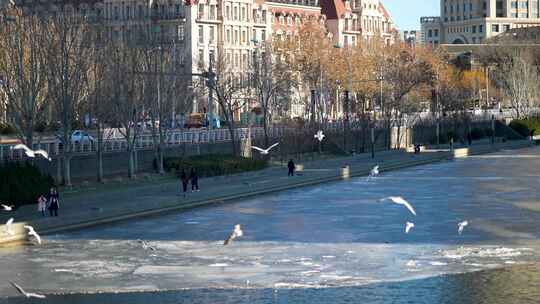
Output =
[{"x1": 0, "y1": 142, "x2": 531, "y2": 245}]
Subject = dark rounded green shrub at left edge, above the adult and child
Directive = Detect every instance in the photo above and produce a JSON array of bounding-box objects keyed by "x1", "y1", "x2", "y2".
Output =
[{"x1": 0, "y1": 163, "x2": 54, "y2": 207}]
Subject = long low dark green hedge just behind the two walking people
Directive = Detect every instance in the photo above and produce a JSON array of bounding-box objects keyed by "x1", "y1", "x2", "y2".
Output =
[{"x1": 163, "y1": 154, "x2": 268, "y2": 177}]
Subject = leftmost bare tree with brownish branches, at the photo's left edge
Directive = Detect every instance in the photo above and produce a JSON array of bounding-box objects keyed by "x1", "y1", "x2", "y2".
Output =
[{"x1": 0, "y1": 8, "x2": 50, "y2": 147}]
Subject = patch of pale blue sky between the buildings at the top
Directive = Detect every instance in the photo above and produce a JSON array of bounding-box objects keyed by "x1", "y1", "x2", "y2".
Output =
[{"x1": 383, "y1": 0, "x2": 440, "y2": 31}]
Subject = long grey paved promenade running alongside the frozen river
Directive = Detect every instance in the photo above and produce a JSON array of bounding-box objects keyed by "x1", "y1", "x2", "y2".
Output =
[{"x1": 0, "y1": 141, "x2": 531, "y2": 243}]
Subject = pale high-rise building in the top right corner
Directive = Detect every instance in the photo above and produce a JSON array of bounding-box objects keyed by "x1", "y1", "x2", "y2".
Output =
[{"x1": 420, "y1": 0, "x2": 540, "y2": 45}]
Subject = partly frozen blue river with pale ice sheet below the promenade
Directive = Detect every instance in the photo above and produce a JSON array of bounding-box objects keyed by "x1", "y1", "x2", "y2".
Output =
[{"x1": 0, "y1": 149, "x2": 540, "y2": 303}]
